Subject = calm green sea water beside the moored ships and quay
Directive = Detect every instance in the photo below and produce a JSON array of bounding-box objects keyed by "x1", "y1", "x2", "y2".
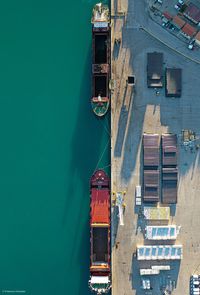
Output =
[{"x1": 0, "y1": 0, "x2": 110, "y2": 295}]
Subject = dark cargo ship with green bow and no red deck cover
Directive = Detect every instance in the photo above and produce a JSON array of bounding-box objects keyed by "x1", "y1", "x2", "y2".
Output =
[{"x1": 91, "y1": 3, "x2": 110, "y2": 117}]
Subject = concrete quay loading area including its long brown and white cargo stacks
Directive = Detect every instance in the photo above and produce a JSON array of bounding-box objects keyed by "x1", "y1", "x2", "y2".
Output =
[{"x1": 111, "y1": 0, "x2": 200, "y2": 295}]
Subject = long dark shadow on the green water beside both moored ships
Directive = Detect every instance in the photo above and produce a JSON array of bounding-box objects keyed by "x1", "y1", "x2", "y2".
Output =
[{"x1": 62, "y1": 50, "x2": 110, "y2": 295}]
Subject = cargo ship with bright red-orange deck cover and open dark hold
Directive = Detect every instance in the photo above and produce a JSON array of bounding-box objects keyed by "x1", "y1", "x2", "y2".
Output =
[{"x1": 89, "y1": 170, "x2": 111, "y2": 294}]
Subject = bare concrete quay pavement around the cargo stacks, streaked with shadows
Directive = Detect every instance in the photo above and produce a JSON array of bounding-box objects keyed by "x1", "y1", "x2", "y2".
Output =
[{"x1": 111, "y1": 0, "x2": 200, "y2": 295}]
